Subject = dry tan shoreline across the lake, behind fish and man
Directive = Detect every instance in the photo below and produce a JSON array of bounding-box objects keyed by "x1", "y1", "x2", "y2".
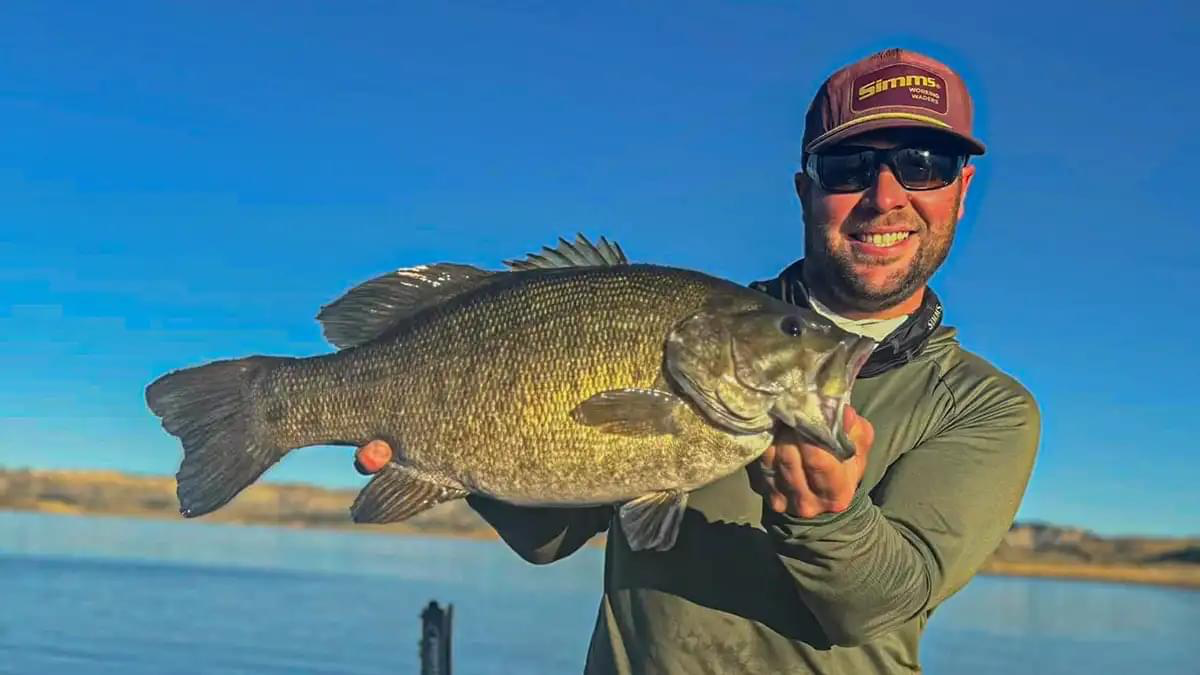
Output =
[{"x1": 0, "y1": 468, "x2": 1200, "y2": 590}]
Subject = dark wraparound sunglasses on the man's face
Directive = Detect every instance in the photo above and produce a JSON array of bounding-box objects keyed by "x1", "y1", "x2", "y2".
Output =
[{"x1": 804, "y1": 148, "x2": 967, "y2": 192}]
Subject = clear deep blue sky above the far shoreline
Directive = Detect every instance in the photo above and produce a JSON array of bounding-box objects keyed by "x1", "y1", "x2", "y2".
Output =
[{"x1": 0, "y1": 0, "x2": 1200, "y2": 534}]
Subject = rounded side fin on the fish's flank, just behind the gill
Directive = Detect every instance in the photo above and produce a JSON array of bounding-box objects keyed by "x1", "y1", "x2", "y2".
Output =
[{"x1": 571, "y1": 389, "x2": 683, "y2": 436}]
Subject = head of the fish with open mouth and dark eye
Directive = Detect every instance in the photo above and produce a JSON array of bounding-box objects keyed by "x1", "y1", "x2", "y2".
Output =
[{"x1": 666, "y1": 301, "x2": 876, "y2": 460}]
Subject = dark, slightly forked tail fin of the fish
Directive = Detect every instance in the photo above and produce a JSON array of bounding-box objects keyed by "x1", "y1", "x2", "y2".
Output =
[{"x1": 146, "y1": 357, "x2": 290, "y2": 518}]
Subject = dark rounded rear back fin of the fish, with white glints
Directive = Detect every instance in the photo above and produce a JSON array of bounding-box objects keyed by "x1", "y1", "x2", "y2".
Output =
[{"x1": 317, "y1": 263, "x2": 496, "y2": 350}]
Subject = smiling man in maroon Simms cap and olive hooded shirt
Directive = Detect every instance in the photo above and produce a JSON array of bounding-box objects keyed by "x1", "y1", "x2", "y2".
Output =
[{"x1": 357, "y1": 49, "x2": 1039, "y2": 674}]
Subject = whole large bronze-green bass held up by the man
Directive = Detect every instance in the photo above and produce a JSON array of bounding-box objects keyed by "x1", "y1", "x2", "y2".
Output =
[{"x1": 146, "y1": 235, "x2": 875, "y2": 550}]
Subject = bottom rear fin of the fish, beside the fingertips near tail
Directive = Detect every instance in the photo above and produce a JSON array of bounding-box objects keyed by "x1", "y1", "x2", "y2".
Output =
[{"x1": 350, "y1": 461, "x2": 469, "y2": 524}]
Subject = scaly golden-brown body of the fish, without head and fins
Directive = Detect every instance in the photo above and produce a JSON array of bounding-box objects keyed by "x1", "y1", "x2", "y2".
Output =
[{"x1": 252, "y1": 265, "x2": 763, "y2": 503}]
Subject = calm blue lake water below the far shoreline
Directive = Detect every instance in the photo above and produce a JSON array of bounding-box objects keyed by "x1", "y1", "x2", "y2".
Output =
[{"x1": 0, "y1": 512, "x2": 1200, "y2": 675}]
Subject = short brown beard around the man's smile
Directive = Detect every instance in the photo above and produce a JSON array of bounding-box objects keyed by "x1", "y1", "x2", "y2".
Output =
[{"x1": 804, "y1": 190, "x2": 961, "y2": 312}]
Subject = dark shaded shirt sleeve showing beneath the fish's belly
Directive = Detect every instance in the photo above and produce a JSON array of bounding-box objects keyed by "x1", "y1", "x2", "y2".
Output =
[{"x1": 467, "y1": 495, "x2": 612, "y2": 565}]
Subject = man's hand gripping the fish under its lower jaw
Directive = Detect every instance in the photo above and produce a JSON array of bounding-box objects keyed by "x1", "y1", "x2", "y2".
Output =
[{"x1": 749, "y1": 406, "x2": 875, "y2": 518}]
